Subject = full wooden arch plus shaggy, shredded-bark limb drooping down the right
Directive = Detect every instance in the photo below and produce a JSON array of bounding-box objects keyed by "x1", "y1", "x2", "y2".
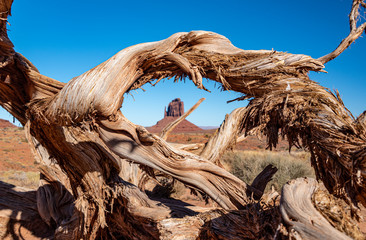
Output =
[{"x1": 30, "y1": 28, "x2": 366, "y2": 209}]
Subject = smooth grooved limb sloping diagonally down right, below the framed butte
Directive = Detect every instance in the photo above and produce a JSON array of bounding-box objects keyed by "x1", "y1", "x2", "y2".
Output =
[{"x1": 99, "y1": 114, "x2": 256, "y2": 209}]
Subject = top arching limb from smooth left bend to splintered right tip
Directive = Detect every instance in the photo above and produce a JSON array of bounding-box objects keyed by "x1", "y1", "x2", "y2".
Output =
[{"x1": 32, "y1": 31, "x2": 323, "y2": 125}]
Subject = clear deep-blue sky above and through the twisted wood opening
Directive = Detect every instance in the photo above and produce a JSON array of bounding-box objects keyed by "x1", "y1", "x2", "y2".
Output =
[{"x1": 0, "y1": 0, "x2": 366, "y2": 126}]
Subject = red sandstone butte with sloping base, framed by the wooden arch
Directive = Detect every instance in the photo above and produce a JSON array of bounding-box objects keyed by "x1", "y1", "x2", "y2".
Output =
[{"x1": 146, "y1": 98, "x2": 203, "y2": 133}]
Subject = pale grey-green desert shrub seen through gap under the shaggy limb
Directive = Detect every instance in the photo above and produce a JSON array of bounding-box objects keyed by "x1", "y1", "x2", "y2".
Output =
[{"x1": 222, "y1": 151, "x2": 315, "y2": 191}]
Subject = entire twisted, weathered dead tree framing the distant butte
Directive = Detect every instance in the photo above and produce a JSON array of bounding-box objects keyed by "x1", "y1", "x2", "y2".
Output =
[{"x1": 0, "y1": 0, "x2": 366, "y2": 239}]
